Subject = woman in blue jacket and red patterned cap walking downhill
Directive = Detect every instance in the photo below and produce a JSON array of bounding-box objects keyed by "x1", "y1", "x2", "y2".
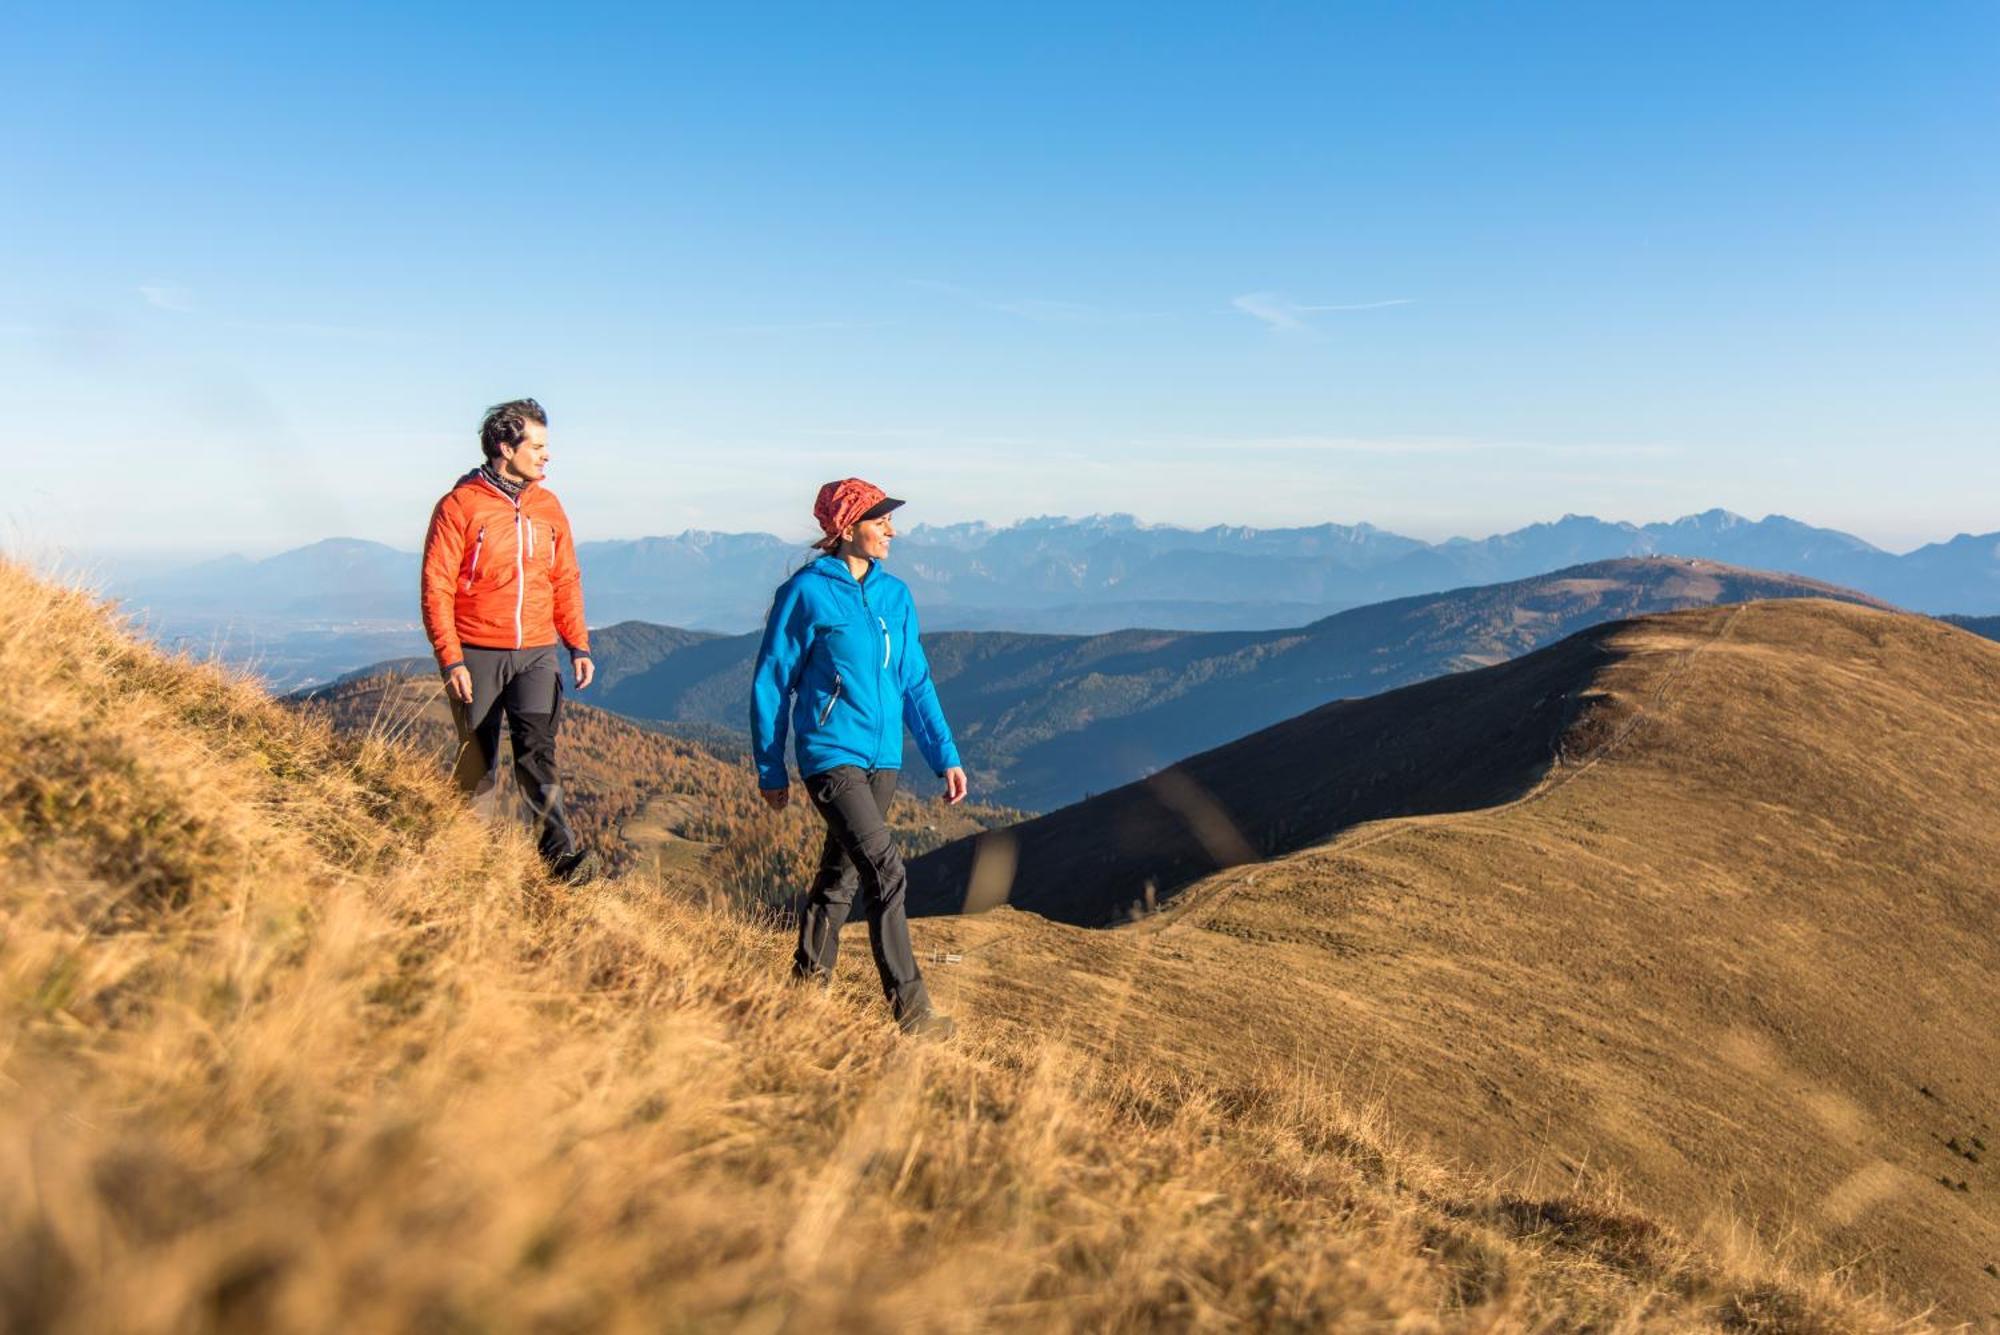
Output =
[{"x1": 750, "y1": 478, "x2": 966, "y2": 1035}]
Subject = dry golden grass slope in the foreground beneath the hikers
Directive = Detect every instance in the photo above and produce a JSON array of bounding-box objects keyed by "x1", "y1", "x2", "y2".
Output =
[{"x1": 0, "y1": 568, "x2": 1936, "y2": 1331}]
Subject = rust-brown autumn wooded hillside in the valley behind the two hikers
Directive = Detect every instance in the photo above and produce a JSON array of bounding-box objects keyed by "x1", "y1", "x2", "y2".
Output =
[{"x1": 296, "y1": 671, "x2": 1018, "y2": 903}]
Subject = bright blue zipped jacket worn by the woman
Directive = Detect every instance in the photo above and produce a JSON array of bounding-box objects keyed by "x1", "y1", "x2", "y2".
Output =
[{"x1": 750, "y1": 556, "x2": 958, "y2": 787}]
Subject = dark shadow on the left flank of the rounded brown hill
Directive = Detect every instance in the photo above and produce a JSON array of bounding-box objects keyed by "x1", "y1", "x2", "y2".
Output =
[{"x1": 910, "y1": 624, "x2": 1618, "y2": 927}]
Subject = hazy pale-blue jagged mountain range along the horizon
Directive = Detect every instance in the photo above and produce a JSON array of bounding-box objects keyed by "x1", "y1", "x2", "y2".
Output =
[{"x1": 110, "y1": 510, "x2": 2000, "y2": 655}]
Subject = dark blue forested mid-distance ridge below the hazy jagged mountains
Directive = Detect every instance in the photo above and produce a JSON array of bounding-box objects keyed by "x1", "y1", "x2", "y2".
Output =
[{"x1": 340, "y1": 558, "x2": 1872, "y2": 811}]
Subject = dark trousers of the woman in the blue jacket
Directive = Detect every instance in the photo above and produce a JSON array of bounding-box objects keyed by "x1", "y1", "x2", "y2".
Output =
[{"x1": 792, "y1": 765, "x2": 930, "y2": 1019}]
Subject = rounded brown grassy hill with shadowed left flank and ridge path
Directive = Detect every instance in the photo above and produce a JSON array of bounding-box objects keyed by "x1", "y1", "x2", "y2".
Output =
[{"x1": 912, "y1": 600, "x2": 2000, "y2": 1325}]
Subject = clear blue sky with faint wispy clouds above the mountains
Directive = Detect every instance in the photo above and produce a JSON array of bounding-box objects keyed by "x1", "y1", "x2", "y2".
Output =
[{"x1": 0, "y1": 2, "x2": 2000, "y2": 554}]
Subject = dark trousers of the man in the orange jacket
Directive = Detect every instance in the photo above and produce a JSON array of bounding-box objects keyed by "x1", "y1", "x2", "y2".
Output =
[{"x1": 446, "y1": 644, "x2": 576, "y2": 863}]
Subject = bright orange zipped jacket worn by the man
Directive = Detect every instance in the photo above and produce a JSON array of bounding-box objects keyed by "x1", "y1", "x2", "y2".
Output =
[{"x1": 424, "y1": 468, "x2": 590, "y2": 671}]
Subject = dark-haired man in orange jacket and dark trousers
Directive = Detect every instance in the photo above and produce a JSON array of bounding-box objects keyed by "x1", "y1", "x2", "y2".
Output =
[{"x1": 422, "y1": 398, "x2": 596, "y2": 879}]
